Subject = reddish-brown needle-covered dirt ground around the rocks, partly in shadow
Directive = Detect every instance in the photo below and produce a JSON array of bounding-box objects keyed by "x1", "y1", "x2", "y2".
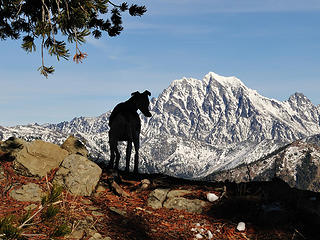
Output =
[{"x1": 0, "y1": 161, "x2": 320, "y2": 240}]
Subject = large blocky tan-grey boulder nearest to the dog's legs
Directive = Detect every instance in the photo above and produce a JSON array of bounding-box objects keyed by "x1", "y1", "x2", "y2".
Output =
[{"x1": 53, "y1": 154, "x2": 102, "y2": 196}]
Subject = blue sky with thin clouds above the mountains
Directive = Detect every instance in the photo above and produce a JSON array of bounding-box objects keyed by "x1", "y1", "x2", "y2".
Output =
[{"x1": 0, "y1": 0, "x2": 320, "y2": 126}]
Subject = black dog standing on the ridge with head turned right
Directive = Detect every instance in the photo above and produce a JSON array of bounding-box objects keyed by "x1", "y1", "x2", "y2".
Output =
[{"x1": 108, "y1": 90, "x2": 151, "y2": 173}]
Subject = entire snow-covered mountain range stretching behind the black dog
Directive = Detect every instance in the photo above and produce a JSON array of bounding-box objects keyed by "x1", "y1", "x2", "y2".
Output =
[{"x1": 0, "y1": 72, "x2": 320, "y2": 178}]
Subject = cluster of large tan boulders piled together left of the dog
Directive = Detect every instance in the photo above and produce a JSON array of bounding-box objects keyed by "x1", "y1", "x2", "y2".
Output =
[{"x1": 0, "y1": 136, "x2": 102, "y2": 197}]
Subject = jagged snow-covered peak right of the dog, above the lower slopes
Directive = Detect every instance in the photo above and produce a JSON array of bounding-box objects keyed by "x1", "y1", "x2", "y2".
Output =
[{"x1": 143, "y1": 73, "x2": 320, "y2": 142}]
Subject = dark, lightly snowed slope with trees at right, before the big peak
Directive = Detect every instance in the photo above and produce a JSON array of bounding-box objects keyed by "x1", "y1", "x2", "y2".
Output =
[{"x1": 206, "y1": 134, "x2": 320, "y2": 192}]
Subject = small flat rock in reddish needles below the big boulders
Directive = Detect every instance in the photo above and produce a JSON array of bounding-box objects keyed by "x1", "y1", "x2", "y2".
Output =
[{"x1": 10, "y1": 183, "x2": 44, "y2": 202}]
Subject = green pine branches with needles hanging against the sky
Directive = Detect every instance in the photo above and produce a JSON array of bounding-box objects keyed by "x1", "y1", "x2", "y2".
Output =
[{"x1": 0, "y1": 0, "x2": 147, "y2": 77}]
